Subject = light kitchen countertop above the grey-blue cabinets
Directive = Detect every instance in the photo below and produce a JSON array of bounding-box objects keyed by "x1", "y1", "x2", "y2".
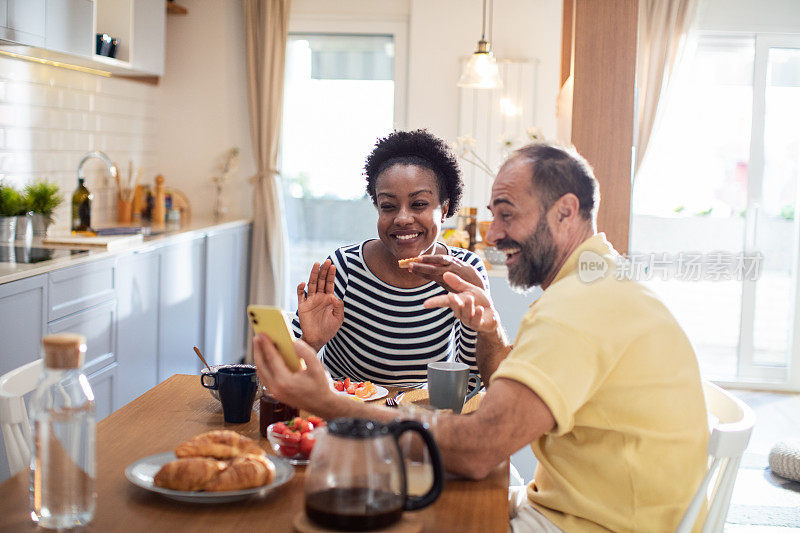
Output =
[{"x1": 0, "y1": 218, "x2": 250, "y2": 285}]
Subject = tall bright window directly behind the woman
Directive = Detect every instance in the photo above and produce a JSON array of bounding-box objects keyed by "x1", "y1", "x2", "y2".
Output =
[{"x1": 279, "y1": 21, "x2": 405, "y2": 307}]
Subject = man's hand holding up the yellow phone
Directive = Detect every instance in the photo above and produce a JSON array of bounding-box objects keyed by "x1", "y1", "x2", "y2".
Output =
[{"x1": 253, "y1": 333, "x2": 337, "y2": 416}]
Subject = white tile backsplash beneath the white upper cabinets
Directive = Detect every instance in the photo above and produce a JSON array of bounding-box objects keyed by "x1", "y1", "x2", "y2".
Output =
[{"x1": 0, "y1": 58, "x2": 157, "y2": 230}]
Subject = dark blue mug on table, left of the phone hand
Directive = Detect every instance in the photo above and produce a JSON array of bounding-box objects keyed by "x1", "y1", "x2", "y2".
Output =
[{"x1": 200, "y1": 366, "x2": 258, "y2": 424}]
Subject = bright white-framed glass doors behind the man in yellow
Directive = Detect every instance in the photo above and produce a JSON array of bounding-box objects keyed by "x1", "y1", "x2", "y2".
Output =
[{"x1": 631, "y1": 33, "x2": 800, "y2": 390}]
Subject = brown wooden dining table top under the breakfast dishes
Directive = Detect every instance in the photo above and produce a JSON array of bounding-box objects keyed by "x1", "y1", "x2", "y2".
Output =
[{"x1": 0, "y1": 375, "x2": 508, "y2": 533}]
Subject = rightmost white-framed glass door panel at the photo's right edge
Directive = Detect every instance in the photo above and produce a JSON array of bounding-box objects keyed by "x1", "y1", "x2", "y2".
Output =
[{"x1": 738, "y1": 35, "x2": 800, "y2": 388}]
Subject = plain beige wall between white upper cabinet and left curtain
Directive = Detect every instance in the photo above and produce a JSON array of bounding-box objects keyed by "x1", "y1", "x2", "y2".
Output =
[{"x1": 156, "y1": 0, "x2": 255, "y2": 218}]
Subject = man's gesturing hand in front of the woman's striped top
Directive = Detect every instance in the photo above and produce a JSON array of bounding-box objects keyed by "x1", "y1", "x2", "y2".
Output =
[{"x1": 423, "y1": 272, "x2": 500, "y2": 333}]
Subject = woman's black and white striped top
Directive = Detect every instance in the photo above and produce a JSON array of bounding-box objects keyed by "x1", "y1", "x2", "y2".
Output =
[{"x1": 292, "y1": 243, "x2": 489, "y2": 386}]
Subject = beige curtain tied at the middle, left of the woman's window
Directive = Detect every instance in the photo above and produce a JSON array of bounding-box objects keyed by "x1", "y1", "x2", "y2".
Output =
[{"x1": 242, "y1": 0, "x2": 290, "y2": 358}]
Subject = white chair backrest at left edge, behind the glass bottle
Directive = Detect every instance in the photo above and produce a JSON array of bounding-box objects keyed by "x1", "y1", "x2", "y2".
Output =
[{"x1": 0, "y1": 359, "x2": 42, "y2": 476}]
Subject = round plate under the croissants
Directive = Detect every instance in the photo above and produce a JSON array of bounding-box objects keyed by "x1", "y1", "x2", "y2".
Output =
[{"x1": 125, "y1": 452, "x2": 294, "y2": 503}]
